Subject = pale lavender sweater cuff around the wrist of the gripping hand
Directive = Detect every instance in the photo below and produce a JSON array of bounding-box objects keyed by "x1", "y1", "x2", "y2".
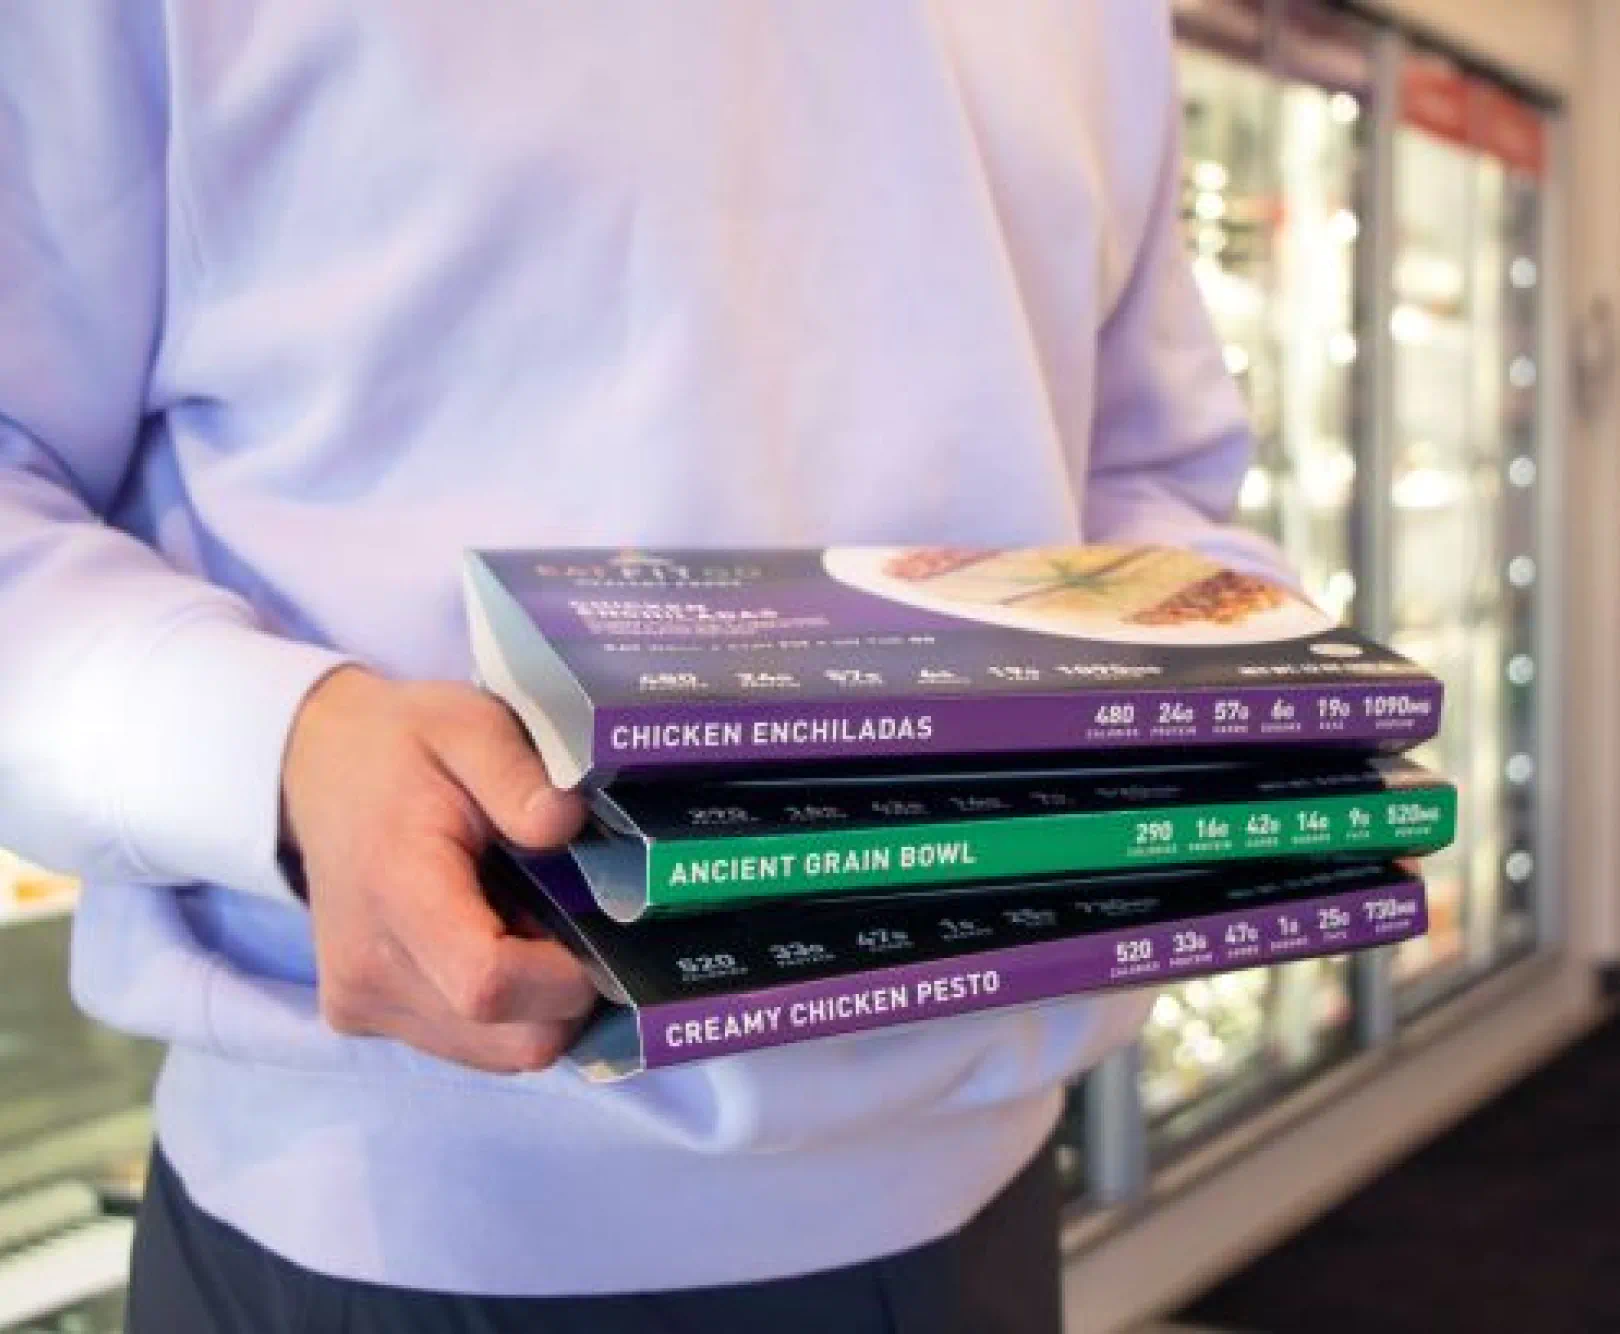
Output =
[{"x1": 112, "y1": 618, "x2": 352, "y2": 901}]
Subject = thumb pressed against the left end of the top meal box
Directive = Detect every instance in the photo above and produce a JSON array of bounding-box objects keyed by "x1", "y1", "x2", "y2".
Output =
[{"x1": 429, "y1": 697, "x2": 585, "y2": 848}]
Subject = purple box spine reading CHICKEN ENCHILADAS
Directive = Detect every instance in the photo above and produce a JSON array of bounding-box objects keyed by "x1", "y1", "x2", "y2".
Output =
[{"x1": 593, "y1": 678, "x2": 1442, "y2": 772}]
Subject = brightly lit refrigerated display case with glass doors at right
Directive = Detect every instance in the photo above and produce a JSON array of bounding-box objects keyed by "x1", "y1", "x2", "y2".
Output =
[{"x1": 1068, "y1": 0, "x2": 1549, "y2": 1198}]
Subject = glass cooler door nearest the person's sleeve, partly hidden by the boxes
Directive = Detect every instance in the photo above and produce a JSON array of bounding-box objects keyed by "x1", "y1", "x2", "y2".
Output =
[{"x1": 1140, "y1": 5, "x2": 1371, "y2": 1152}]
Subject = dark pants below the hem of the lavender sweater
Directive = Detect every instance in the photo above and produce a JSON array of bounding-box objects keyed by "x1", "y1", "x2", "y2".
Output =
[{"x1": 128, "y1": 1151, "x2": 1061, "y2": 1334}]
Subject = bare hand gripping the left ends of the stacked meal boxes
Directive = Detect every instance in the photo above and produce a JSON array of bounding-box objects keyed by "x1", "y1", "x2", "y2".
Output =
[{"x1": 282, "y1": 668, "x2": 596, "y2": 1071}]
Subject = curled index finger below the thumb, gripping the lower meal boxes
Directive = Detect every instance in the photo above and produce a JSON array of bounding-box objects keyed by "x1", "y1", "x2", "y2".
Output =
[{"x1": 386, "y1": 841, "x2": 596, "y2": 1024}]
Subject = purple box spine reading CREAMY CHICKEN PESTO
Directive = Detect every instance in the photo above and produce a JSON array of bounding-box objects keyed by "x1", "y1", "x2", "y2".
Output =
[{"x1": 637, "y1": 879, "x2": 1427, "y2": 1070}]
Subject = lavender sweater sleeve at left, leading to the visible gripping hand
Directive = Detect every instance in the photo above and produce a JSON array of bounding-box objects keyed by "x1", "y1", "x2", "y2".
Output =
[{"x1": 0, "y1": 0, "x2": 351, "y2": 895}]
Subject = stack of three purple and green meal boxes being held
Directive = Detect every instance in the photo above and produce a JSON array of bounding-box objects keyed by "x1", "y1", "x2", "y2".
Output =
[{"x1": 467, "y1": 546, "x2": 1456, "y2": 1080}]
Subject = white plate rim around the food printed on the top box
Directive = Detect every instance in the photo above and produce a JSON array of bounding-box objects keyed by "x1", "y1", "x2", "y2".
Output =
[{"x1": 821, "y1": 546, "x2": 1337, "y2": 647}]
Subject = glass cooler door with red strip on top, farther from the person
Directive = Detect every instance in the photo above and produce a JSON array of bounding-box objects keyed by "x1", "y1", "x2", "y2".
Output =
[{"x1": 1390, "y1": 55, "x2": 1542, "y2": 1013}]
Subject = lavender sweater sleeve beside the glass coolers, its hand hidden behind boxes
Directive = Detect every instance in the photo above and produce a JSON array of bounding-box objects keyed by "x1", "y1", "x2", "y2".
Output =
[{"x1": 1084, "y1": 6, "x2": 1294, "y2": 584}]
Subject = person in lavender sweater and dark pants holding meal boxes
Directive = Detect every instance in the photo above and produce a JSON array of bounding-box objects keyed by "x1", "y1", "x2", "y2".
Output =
[{"x1": 0, "y1": 0, "x2": 1268, "y2": 1334}]
